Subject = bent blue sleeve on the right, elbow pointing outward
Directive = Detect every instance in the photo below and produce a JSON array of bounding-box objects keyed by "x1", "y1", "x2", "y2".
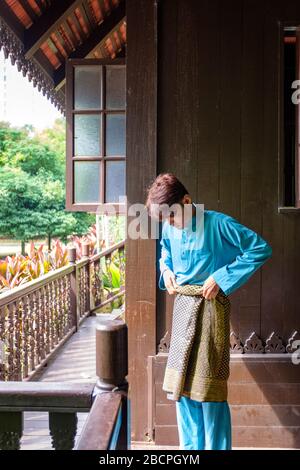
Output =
[{"x1": 212, "y1": 216, "x2": 272, "y2": 295}]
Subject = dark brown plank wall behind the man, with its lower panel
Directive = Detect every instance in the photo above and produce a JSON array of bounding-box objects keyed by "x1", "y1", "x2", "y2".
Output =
[{"x1": 150, "y1": 0, "x2": 300, "y2": 447}]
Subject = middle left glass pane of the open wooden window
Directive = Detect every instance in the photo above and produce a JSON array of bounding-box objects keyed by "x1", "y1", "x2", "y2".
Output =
[{"x1": 74, "y1": 114, "x2": 101, "y2": 156}]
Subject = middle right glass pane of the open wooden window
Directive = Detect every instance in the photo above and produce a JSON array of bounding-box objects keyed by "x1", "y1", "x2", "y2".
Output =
[{"x1": 106, "y1": 114, "x2": 126, "y2": 155}]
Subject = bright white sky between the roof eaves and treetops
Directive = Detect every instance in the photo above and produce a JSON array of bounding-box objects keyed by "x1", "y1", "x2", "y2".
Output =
[{"x1": 0, "y1": 51, "x2": 62, "y2": 129}]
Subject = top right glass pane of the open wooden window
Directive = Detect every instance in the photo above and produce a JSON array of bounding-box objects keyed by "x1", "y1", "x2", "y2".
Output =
[{"x1": 106, "y1": 65, "x2": 126, "y2": 109}]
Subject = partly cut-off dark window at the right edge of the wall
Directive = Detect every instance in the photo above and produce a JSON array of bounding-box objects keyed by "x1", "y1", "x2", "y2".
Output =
[{"x1": 281, "y1": 26, "x2": 300, "y2": 208}]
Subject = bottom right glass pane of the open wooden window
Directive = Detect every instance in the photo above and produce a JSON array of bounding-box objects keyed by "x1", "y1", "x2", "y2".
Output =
[{"x1": 105, "y1": 161, "x2": 125, "y2": 202}]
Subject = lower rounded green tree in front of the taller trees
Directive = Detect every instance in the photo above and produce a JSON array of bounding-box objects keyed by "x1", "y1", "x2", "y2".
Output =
[{"x1": 0, "y1": 166, "x2": 93, "y2": 250}]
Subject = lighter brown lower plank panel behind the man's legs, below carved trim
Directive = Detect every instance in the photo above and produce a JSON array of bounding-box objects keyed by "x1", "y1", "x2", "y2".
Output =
[{"x1": 151, "y1": 354, "x2": 300, "y2": 449}]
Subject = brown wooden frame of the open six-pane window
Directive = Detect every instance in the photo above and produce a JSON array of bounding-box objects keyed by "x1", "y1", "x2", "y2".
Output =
[{"x1": 66, "y1": 57, "x2": 127, "y2": 215}]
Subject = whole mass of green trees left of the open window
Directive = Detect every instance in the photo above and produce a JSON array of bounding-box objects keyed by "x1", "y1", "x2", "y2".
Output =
[{"x1": 0, "y1": 119, "x2": 95, "y2": 241}]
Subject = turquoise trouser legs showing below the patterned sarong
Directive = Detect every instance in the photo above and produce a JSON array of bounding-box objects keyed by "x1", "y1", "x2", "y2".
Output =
[{"x1": 176, "y1": 396, "x2": 231, "y2": 450}]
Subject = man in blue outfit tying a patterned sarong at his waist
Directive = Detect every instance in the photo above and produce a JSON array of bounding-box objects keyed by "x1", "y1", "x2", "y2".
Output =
[{"x1": 146, "y1": 173, "x2": 272, "y2": 450}]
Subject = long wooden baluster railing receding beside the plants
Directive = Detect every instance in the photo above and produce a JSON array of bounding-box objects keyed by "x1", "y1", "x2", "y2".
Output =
[{"x1": 0, "y1": 242, "x2": 125, "y2": 381}]
